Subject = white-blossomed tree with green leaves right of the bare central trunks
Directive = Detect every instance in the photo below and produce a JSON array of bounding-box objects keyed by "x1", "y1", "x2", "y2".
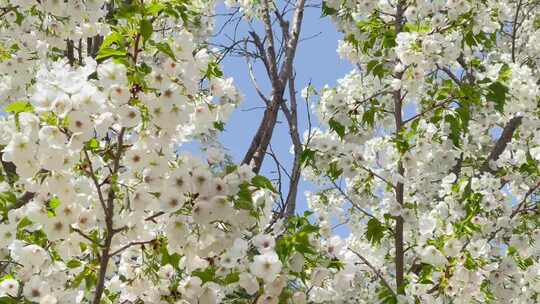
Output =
[{"x1": 304, "y1": 0, "x2": 540, "y2": 303}]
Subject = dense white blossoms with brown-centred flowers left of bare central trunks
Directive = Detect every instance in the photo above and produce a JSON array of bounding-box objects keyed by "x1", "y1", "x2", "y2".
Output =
[{"x1": 0, "y1": 0, "x2": 340, "y2": 304}]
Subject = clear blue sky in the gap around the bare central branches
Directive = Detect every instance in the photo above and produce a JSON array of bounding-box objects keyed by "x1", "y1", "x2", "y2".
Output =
[{"x1": 214, "y1": 5, "x2": 351, "y2": 213}]
